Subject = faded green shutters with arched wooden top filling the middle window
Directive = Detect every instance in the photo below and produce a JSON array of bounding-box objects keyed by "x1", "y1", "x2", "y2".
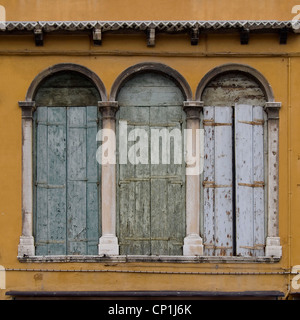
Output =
[{"x1": 117, "y1": 73, "x2": 185, "y2": 255}]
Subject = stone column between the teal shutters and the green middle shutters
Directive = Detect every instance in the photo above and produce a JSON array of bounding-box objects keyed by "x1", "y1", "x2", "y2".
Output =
[{"x1": 98, "y1": 101, "x2": 119, "y2": 256}]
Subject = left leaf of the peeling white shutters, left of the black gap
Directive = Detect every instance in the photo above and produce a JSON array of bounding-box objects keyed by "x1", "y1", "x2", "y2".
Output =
[{"x1": 203, "y1": 107, "x2": 233, "y2": 256}]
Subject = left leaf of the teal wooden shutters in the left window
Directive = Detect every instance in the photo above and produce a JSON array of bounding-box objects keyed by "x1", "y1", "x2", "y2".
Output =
[{"x1": 35, "y1": 107, "x2": 67, "y2": 255}]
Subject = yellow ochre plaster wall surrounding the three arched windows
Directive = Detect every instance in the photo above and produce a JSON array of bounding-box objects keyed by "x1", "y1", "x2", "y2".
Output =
[{"x1": 0, "y1": 0, "x2": 300, "y2": 300}]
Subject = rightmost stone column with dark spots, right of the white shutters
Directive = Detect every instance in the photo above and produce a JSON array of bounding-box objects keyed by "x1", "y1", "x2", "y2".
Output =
[{"x1": 265, "y1": 102, "x2": 282, "y2": 258}]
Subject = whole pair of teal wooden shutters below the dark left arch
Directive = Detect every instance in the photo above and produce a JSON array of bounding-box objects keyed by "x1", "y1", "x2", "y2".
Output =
[{"x1": 35, "y1": 107, "x2": 100, "y2": 255}]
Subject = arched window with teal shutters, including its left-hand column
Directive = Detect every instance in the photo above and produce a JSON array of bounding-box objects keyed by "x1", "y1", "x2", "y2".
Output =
[{"x1": 19, "y1": 65, "x2": 103, "y2": 256}]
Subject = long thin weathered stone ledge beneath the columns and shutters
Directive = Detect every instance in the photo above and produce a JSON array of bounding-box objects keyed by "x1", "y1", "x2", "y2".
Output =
[{"x1": 18, "y1": 255, "x2": 280, "y2": 263}]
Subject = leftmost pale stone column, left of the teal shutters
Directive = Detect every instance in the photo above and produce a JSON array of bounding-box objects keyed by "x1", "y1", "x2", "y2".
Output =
[{"x1": 18, "y1": 101, "x2": 35, "y2": 257}]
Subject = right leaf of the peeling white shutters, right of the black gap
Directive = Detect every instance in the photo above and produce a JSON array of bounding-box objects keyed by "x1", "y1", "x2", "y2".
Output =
[{"x1": 235, "y1": 105, "x2": 264, "y2": 256}]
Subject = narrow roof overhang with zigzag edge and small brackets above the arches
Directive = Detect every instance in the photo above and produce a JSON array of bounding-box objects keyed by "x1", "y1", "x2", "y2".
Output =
[{"x1": 0, "y1": 20, "x2": 300, "y2": 46}]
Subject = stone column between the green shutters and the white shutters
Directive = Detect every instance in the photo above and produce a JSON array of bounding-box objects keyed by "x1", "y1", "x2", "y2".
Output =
[{"x1": 183, "y1": 101, "x2": 203, "y2": 256}]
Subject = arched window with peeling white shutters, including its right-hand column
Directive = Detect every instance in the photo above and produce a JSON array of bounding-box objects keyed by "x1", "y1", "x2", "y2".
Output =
[{"x1": 197, "y1": 66, "x2": 281, "y2": 257}]
